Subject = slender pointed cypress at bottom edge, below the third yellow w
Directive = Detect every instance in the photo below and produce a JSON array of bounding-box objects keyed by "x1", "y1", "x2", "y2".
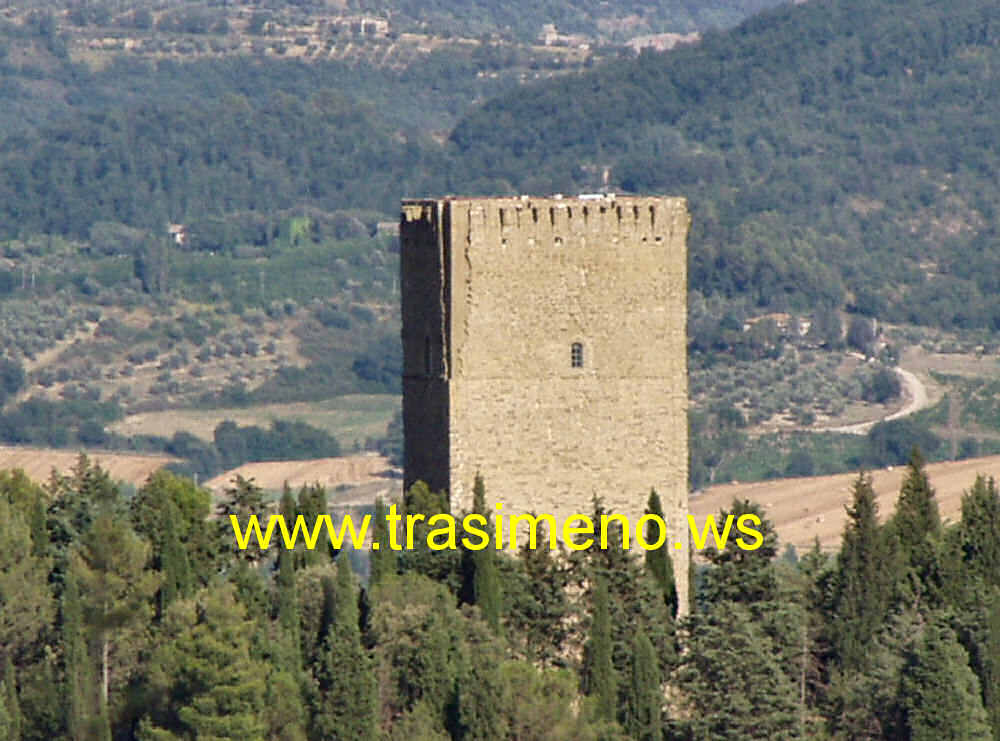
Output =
[{"x1": 313, "y1": 558, "x2": 378, "y2": 741}]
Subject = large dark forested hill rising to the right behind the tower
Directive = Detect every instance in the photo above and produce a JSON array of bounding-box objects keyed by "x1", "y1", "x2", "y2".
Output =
[{"x1": 451, "y1": 0, "x2": 1000, "y2": 329}]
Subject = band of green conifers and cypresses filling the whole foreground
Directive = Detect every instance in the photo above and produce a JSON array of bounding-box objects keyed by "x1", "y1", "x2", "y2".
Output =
[{"x1": 0, "y1": 457, "x2": 1000, "y2": 741}]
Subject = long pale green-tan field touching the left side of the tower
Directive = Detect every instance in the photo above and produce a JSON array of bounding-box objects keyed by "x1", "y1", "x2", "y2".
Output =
[{"x1": 108, "y1": 394, "x2": 400, "y2": 448}]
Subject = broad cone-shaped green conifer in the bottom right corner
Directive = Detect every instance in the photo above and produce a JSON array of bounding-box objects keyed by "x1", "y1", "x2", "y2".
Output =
[{"x1": 901, "y1": 624, "x2": 991, "y2": 741}]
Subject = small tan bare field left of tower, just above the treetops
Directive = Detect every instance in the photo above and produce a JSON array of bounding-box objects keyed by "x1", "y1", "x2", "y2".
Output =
[{"x1": 205, "y1": 454, "x2": 402, "y2": 505}]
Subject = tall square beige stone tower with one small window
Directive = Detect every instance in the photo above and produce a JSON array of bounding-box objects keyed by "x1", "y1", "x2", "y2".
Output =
[{"x1": 400, "y1": 195, "x2": 690, "y2": 611}]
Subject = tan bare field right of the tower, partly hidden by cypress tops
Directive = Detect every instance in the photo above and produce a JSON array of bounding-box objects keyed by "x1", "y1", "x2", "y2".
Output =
[{"x1": 690, "y1": 456, "x2": 1000, "y2": 553}]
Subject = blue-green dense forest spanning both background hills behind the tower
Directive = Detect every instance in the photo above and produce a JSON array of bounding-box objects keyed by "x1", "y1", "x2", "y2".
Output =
[{"x1": 0, "y1": 0, "x2": 1000, "y2": 329}]
